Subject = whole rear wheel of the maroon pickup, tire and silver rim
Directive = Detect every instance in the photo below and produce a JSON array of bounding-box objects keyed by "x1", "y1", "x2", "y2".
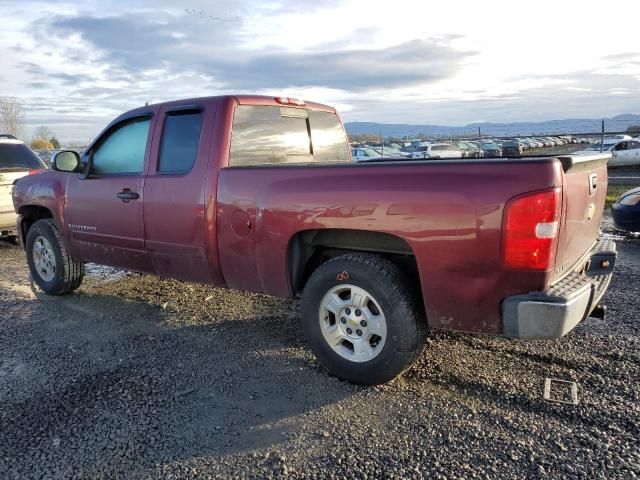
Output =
[{"x1": 301, "y1": 254, "x2": 427, "y2": 385}]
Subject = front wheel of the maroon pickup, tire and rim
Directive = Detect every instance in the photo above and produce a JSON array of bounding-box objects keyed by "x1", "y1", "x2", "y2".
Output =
[{"x1": 26, "y1": 219, "x2": 84, "y2": 295}]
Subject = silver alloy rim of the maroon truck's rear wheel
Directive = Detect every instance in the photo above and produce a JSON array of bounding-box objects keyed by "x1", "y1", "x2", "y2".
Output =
[{"x1": 319, "y1": 285, "x2": 387, "y2": 363}]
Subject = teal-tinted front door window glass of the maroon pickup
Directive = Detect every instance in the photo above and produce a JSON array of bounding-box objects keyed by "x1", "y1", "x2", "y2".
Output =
[{"x1": 91, "y1": 117, "x2": 151, "y2": 175}]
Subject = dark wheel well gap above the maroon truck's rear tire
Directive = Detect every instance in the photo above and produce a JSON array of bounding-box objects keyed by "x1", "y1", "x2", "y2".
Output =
[{"x1": 287, "y1": 228, "x2": 420, "y2": 295}]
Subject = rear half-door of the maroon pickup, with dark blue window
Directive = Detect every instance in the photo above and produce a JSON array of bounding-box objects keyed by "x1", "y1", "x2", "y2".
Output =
[{"x1": 143, "y1": 102, "x2": 216, "y2": 283}]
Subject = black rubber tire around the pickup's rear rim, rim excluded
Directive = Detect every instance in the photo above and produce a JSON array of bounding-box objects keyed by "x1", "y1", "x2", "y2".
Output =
[{"x1": 301, "y1": 254, "x2": 427, "y2": 385}]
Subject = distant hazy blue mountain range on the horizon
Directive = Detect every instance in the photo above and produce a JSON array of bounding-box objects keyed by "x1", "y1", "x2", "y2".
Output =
[{"x1": 345, "y1": 113, "x2": 640, "y2": 138}]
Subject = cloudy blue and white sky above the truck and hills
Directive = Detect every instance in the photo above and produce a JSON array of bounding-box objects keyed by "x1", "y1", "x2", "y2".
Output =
[{"x1": 0, "y1": 0, "x2": 640, "y2": 142}]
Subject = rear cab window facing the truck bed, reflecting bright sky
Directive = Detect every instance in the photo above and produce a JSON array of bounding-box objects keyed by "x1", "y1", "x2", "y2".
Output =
[{"x1": 229, "y1": 105, "x2": 351, "y2": 166}]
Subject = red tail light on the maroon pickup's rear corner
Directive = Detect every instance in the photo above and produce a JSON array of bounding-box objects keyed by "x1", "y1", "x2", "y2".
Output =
[{"x1": 502, "y1": 188, "x2": 562, "y2": 271}]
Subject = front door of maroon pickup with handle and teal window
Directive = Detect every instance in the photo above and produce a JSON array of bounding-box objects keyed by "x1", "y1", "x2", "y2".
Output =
[{"x1": 64, "y1": 114, "x2": 152, "y2": 272}]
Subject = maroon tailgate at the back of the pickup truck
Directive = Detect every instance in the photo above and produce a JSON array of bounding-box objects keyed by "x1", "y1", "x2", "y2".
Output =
[{"x1": 552, "y1": 153, "x2": 611, "y2": 281}]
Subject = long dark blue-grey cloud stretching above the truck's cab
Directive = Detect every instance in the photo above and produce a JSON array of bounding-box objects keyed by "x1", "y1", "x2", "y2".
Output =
[{"x1": 50, "y1": 14, "x2": 474, "y2": 90}]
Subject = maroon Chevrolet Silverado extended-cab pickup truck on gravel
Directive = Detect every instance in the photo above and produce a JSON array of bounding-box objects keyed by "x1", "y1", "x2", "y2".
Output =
[{"x1": 13, "y1": 96, "x2": 616, "y2": 384}]
